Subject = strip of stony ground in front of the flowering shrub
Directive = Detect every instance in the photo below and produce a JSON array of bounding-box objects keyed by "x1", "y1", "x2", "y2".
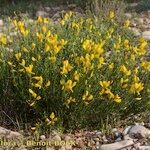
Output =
[{"x1": 0, "y1": 123, "x2": 150, "y2": 150}]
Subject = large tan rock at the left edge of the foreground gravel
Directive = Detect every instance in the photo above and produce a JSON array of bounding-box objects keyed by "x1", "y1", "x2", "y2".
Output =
[{"x1": 0, "y1": 127, "x2": 23, "y2": 139}]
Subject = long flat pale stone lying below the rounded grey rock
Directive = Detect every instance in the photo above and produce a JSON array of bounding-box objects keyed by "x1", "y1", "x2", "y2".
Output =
[{"x1": 100, "y1": 140, "x2": 134, "y2": 150}]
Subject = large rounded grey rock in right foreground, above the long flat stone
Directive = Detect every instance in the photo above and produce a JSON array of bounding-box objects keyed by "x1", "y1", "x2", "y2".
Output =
[{"x1": 129, "y1": 125, "x2": 150, "y2": 138}]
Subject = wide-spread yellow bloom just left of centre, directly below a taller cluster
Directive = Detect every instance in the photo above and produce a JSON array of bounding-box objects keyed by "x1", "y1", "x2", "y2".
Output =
[{"x1": 60, "y1": 80, "x2": 76, "y2": 92}]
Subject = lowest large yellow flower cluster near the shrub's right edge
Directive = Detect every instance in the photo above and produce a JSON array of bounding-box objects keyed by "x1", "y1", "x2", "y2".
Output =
[{"x1": 130, "y1": 82, "x2": 144, "y2": 94}]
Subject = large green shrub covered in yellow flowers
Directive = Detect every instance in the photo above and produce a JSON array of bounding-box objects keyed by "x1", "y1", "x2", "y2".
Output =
[{"x1": 0, "y1": 11, "x2": 150, "y2": 128}]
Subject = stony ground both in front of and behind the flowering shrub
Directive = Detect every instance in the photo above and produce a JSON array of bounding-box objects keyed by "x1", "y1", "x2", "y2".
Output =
[{"x1": 0, "y1": 1, "x2": 150, "y2": 150}]
